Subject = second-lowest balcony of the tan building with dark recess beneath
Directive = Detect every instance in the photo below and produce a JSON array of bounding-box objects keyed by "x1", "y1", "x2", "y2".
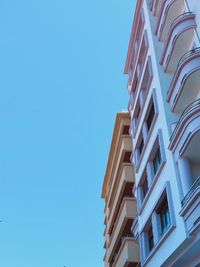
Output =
[{"x1": 108, "y1": 197, "x2": 137, "y2": 261}]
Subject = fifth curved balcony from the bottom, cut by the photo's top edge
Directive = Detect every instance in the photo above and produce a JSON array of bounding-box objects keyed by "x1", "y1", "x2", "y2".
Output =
[{"x1": 155, "y1": 0, "x2": 185, "y2": 41}]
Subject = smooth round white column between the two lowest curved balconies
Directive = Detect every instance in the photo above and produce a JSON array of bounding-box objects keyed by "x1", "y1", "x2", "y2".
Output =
[{"x1": 177, "y1": 157, "x2": 193, "y2": 196}]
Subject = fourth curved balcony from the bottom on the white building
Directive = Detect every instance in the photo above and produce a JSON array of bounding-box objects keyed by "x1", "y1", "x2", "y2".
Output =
[{"x1": 160, "y1": 12, "x2": 196, "y2": 72}]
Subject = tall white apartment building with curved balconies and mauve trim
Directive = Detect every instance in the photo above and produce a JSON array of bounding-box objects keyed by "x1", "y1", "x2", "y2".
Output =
[{"x1": 123, "y1": 0, "x2": 200, "y2": 267}]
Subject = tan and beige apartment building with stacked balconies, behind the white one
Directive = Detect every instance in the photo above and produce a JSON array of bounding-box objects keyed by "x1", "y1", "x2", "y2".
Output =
[{"x1": 102, "y1": 112, "x2": 140, "y2": 267}]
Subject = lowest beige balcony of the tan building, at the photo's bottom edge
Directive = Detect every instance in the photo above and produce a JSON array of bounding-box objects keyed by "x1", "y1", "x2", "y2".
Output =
[{"x1": 112, "y1": 237, "x2": 140, "y2": 267}]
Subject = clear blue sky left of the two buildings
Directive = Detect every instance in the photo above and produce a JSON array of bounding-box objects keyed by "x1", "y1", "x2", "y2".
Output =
[{"x1": 0, "y1": 0, "x2": 135, "y2": 267}]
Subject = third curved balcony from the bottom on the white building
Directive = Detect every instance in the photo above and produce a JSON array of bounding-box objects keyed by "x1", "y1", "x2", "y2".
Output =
[{"x1": 167, "y1": 48, "x2": 200, "y2": 114}]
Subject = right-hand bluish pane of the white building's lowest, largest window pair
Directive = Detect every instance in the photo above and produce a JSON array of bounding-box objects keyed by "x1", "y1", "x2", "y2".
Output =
[{"x1": 157, "y1": 196, "x2": 171, "y2": 235}]
